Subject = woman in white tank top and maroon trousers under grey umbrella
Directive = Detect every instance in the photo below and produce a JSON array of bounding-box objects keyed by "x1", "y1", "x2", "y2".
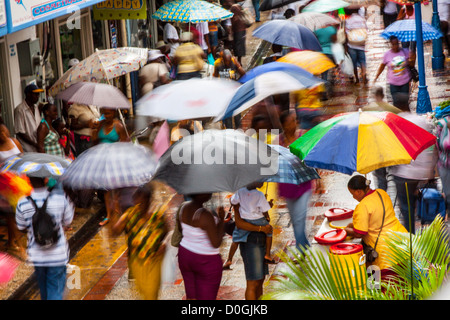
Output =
[{"x1": 178, "y1": 194, "x2": 225, "y2": 300}]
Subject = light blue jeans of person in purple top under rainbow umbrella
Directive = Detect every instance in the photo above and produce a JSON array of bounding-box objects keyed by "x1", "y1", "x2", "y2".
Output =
[{"x1": 286, "y1": 190, "x2": 312, "y2": 251}]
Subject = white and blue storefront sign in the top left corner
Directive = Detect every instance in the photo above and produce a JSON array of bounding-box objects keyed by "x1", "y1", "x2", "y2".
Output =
[{"x1": 6, "y1": 0, "x2": 103, "y2": 32}]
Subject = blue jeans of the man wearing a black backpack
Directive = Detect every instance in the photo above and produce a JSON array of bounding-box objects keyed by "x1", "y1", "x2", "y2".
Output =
[{"x1": 34, "y1": 265, "x2": 66, "y2": 300}]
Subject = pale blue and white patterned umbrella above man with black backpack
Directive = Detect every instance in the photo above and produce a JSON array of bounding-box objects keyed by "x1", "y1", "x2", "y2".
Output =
[{"x1": 0, "y1": 152, "x2": 70, "y2": 178}]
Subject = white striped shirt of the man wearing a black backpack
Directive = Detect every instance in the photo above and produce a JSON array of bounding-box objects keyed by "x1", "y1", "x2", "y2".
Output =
[{"x1": 16, "y1": 188, "x2": 74, "y2": 267}]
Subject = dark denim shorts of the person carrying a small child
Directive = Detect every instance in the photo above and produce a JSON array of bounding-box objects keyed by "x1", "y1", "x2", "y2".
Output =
[{"x1": 239, "y1": 232, "x2": 269, "y2": 280}]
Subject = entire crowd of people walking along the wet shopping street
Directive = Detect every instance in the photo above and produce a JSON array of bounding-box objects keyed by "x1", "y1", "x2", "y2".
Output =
[{"x1": 0, "y1": 0, "x2": 450, "y2": 300}]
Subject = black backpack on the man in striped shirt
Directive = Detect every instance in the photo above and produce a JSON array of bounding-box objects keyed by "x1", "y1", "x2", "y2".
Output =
[{"x1": 27, "y1": 190, "x2": 60, "y2": 247}]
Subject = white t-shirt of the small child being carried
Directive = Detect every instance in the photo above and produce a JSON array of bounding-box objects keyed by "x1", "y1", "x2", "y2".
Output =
[{"x1": 231, "y1": 188, "x2": 270, "y2": 220}]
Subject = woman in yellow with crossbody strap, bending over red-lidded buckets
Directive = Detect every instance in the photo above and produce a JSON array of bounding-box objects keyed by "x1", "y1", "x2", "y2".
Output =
[{"x1": 345, "y1": 175, "x2": 407, "y2": 279}]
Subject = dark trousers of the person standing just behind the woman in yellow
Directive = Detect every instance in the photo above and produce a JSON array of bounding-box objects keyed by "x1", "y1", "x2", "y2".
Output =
[{"x1": 394, "y1": 176, "x2": 419, "y2": 233}]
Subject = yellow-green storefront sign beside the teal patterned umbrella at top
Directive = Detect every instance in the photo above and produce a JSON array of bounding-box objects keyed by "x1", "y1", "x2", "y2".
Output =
[{"x1": 94, "y1": 0, "x2": 147, "y2": 20}]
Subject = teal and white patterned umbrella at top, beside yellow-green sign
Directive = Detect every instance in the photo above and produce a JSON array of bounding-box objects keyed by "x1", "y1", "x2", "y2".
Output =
[{"x1": 152, "y1": 0, "x2": 233, "y2": 23}]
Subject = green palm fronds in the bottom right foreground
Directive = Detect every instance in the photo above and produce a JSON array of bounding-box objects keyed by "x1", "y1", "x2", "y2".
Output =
[{"x1": 262, "y1": 216, "x2": 450, "y2": 300}]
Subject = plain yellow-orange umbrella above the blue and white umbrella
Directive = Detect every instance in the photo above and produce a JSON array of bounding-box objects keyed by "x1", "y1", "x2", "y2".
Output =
[{"x1": 277, "y1": 50, "x2": 336, "y2": 75}]
